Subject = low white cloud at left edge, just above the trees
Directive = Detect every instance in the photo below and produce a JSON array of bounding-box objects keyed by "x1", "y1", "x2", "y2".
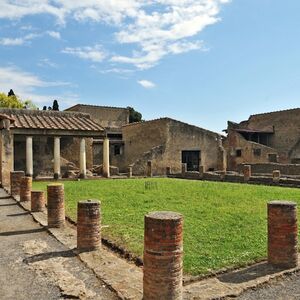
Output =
[{"x1": 0, "y1": 66, "x2": 70, "y2": 104}]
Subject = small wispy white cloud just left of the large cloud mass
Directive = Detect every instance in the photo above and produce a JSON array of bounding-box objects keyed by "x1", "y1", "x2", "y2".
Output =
[{"x1": 62, "y1": 45, "x2": 106, "y2": 62}]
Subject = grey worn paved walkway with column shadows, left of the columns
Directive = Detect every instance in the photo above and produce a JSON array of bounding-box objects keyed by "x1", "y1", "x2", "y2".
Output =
[{"x1": 0, "y1": 189, "x2": 117, "y2": 300}]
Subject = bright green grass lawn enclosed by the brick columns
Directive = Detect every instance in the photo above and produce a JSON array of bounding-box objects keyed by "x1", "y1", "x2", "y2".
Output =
[{"x1": 33, "y1": 179, "x2": 300, "y2": 275}]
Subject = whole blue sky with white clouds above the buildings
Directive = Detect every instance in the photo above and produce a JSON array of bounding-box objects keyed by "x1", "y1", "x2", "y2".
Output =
[{"x1": 0, "y1": 0, "x2": 300, "y2": 132}]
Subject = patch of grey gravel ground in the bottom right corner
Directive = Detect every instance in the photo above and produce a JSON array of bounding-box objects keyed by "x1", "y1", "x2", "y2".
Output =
[{"x1": 236, "y1": 272, "x2": 300, "y2": 300}]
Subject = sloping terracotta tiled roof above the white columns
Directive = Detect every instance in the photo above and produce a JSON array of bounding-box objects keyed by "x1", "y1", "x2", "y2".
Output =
[{"x1": 0, "y1": 108, "x2": 104, "y2": 132}]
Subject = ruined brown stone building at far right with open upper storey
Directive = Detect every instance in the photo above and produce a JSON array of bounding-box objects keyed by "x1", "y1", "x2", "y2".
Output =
[{"x1": 224, "y1": 108, "x2": 300, "y2": 170}]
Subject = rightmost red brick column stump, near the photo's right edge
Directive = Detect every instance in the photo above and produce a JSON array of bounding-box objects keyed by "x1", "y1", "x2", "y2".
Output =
[{"x1": 268, "y1": 201, "x2": 298, "y2": 268}]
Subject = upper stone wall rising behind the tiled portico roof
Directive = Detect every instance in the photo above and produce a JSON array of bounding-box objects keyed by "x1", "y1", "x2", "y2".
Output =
[{"x1": 67, "y1": 104, "x2": 129, "y2": 128}]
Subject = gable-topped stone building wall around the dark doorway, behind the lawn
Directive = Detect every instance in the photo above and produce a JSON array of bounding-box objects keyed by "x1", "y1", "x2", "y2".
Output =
[{"x1": 122, "y1": 118, "x2": 224, "y2": 175}]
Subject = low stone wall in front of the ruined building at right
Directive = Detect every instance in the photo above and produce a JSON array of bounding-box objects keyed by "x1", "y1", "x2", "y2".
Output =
[{"x1": 238, "y1": 163, "x2": 300, "y2": 176}]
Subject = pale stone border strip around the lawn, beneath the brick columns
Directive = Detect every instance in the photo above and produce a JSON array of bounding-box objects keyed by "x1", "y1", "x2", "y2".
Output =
[{"x1": 11, "y1": 194, "x2": 300, "y2": 300}]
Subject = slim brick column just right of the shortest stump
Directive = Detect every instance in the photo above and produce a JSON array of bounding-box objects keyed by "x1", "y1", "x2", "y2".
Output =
[{"x1": 47, "y1": 183, "x2": 65, "y2": 228}]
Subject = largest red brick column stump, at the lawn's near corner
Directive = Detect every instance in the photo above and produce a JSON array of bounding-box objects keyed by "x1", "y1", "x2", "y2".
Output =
[{"x1": 143, "y1": 211, "x2": 183, "y2": 300}]
